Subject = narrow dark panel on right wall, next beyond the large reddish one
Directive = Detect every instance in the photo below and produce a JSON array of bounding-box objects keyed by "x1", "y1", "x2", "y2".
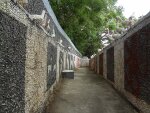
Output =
[{"x1": 107, "y1": 47, "x2": 114, "y2": 82}]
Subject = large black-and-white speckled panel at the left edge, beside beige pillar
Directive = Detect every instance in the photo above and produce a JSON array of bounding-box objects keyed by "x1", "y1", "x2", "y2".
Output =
[{"x1": 0, "y1": 11, "x2": 27, "y2": 113}]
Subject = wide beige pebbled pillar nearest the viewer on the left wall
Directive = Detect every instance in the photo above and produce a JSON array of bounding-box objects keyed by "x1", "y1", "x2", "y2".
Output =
[{"x1": 25, "y1": 25, "x2": 47, "y2": 113}]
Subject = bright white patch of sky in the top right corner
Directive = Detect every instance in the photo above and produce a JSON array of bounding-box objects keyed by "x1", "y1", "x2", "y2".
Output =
[{"x1": 116, "y1": 0, "x2": 150, "y2": 18}]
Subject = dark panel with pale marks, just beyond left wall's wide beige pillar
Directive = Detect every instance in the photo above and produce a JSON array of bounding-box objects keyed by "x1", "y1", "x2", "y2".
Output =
[{"x1": 47, "y1": 43, "x2": 57, "y2": 89}]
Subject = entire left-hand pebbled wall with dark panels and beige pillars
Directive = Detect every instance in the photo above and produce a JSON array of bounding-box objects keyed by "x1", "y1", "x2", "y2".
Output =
[{"x1": 0, "y1": 0, "x2": 81, "y2": 113}]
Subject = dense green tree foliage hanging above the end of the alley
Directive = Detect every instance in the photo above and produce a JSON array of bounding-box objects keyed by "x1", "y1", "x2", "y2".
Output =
[{"x1": 49, "y1": 0, "x2": 124, "y2": 57}]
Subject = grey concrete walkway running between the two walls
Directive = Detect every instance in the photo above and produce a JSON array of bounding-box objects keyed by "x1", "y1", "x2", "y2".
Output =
[{"x1": 49, "y1": 68, "x2": 137, "y2": 113}]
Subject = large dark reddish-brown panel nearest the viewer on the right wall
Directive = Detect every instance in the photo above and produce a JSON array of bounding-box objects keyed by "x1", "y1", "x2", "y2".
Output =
[{"x1": 124, "y1": 25, "x2": 150, "y2": 104}]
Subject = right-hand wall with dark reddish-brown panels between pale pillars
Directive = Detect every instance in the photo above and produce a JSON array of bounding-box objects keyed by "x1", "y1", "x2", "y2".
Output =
[{"x1": 89, "y1": 13, "x2": 150, "y2": 113}]
